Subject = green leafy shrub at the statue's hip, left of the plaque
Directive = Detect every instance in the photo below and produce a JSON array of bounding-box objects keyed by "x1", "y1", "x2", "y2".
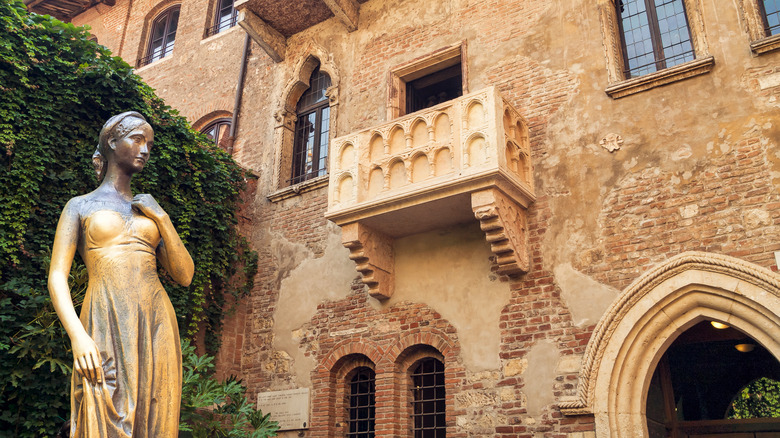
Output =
[{"x1": 179, "y1": 340, "x2": 279, "y2": 438}]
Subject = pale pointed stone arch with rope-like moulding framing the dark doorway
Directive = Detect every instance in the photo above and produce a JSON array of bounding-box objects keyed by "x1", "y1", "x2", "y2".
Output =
[{"x1": 559, "y1": 252, "x2": 780, "y2": 438}]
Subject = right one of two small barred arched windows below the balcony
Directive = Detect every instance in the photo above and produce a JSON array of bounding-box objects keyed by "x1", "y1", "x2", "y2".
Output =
[{"x1": 411, "y1": 357, "x2": 447, "y2": 438}]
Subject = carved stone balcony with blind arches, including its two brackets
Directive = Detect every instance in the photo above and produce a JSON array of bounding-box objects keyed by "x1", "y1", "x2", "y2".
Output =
[{"x1": 326, "y1": 87, "x2": 535, "y2": 299}]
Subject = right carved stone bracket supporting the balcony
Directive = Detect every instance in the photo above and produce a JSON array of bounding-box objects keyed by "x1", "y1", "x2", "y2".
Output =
[{"x1": 471, "y1": 188, "x2": 530, "y2": 275}]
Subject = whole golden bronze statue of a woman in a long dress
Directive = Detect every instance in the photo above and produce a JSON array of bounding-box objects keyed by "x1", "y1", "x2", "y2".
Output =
[{"x1": 49, "y1": 111, "x2": 194, "y2": 438}]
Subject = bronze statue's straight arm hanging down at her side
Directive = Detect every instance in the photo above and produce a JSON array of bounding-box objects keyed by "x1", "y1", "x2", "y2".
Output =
[{"x1": 49, "y1": 199, "x2": 103, "y2": 383}]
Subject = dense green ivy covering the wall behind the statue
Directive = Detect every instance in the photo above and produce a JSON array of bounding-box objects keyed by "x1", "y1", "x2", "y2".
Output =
[{"x1": 0, "y1": 0, "x2": 257, "y2": 437}]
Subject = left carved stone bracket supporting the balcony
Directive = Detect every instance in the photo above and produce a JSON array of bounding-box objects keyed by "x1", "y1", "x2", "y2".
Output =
[{"x1": 341, "y1": 222, "x2": 395, "y2": 300}]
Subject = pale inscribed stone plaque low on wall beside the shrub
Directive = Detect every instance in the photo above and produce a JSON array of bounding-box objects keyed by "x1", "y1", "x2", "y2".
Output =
[{"x1": 257, "y1": 388, "x2": 309, "y2": 430}]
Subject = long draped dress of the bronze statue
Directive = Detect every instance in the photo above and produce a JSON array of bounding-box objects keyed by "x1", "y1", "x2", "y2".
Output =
[{"x1": 71, "y1": 208, "x2": 182, "y2": 438}]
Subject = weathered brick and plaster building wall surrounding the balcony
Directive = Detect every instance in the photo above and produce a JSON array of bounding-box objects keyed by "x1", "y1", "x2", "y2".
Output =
[{"x1": 68, "y1": 0, "x2": 780, "y2": 438}]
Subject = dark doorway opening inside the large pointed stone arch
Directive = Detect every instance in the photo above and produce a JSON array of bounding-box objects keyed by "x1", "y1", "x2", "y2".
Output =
[{"x1": 646, "y1": 321, "x2": 780, "y2": 438}]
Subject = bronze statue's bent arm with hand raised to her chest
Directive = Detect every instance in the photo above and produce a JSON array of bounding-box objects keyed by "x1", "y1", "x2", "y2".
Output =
[{"x1": 132, "y1": 194, "x2": 195, "y2": 286}]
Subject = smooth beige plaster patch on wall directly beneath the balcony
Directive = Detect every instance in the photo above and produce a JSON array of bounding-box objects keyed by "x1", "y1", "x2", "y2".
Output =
[{"x1": 390, "y1": 224, "x2": 510, "y2": 372}]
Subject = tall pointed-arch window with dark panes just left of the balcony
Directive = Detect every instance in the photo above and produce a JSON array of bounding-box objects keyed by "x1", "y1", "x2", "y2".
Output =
[{"x1": 289, "y1": 67, "x2": 331, "y2": 184}]
